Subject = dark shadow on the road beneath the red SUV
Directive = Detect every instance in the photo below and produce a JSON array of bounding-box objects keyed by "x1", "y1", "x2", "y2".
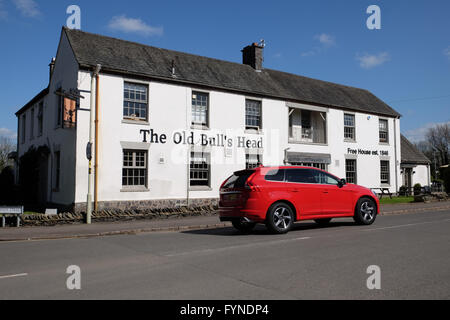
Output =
[{"x1": 182, "y1": 221, "x2": 355, "y2": 237}]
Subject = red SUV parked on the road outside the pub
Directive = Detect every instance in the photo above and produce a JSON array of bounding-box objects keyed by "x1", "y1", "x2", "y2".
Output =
[{"x1": 219, "y1": 167, "x2": 380, "y2": 234}]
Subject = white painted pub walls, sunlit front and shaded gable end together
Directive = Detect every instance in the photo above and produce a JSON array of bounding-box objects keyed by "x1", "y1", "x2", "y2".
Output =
[{"x1": 19, "y1": 33, "x2": 404, "y2": 205}]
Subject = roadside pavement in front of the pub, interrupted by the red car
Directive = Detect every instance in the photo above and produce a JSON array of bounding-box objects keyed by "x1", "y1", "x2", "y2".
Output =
[{"x1": 0, "y1": 202, "x2": 450, "y2": 242}]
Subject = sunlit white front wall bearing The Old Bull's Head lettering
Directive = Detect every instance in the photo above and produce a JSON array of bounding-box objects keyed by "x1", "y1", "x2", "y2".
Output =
[{"x1": 75, "y1": 71, "x2": 400, "y2": 203}]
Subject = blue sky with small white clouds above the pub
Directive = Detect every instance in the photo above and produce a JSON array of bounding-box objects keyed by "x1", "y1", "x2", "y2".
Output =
[{"x1": 0, "y1": 0, "x2": 450, "y2": 140}]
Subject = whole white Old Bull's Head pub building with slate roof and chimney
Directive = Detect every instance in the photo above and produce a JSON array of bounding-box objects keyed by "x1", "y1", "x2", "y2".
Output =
[{"x1": 13, "y1": 28, "x2": 429, "y2": 211}]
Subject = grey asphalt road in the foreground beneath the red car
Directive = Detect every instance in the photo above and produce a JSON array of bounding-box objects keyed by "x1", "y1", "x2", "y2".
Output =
[{"x1": 0, "y1": 211, "x2": 450, "y2": 300}]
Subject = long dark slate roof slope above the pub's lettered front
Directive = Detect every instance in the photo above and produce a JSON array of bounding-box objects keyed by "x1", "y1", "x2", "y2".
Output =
[{"x1": 63, "y1": 27, "x2": 401, "y2": 117}]
